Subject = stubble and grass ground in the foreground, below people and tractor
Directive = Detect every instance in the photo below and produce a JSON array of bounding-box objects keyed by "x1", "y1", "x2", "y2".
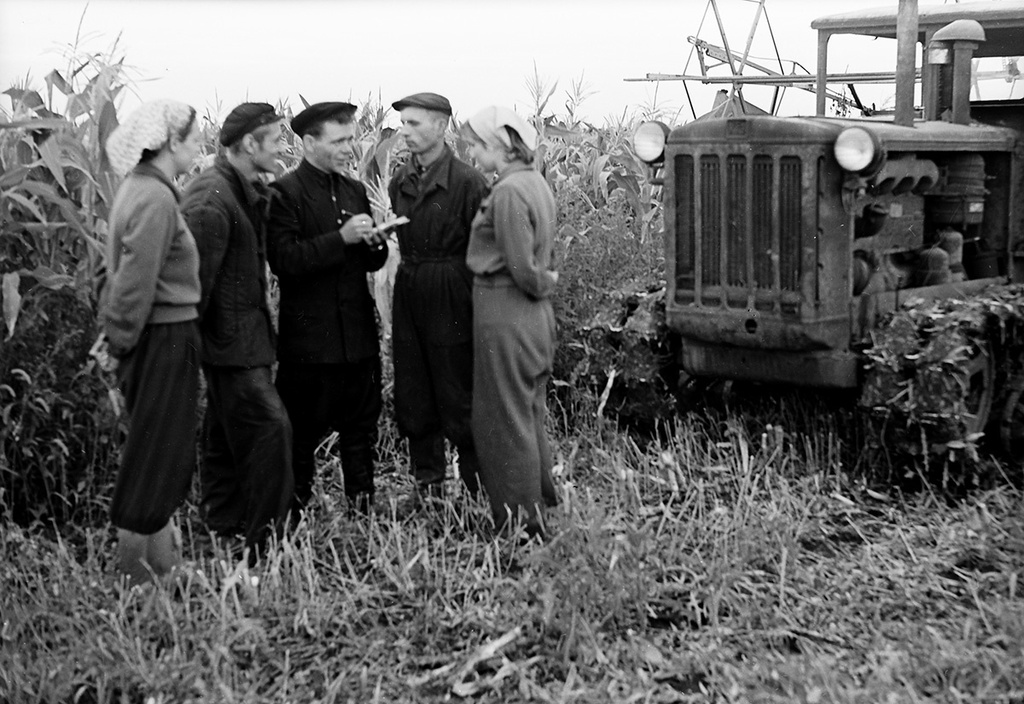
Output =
[{"x1": 0, "y1": 401, "x2": 1024, "y2": 703}]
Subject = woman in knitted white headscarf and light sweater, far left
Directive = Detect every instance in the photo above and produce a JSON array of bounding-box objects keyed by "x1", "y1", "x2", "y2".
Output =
[{"x1": 100, "y1": 100, "x2": 201, "y2": 582}]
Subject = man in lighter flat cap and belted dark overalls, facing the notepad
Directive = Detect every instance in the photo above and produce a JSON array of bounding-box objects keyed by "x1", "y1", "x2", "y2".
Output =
[{"x1": 388, "y1": 93, "x2": 487, "y2": 497}]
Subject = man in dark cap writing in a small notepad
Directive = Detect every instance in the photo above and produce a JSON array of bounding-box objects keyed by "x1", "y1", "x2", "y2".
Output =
[{"x1": 268, "y1": 102, "x2": 388, "y2": 513}]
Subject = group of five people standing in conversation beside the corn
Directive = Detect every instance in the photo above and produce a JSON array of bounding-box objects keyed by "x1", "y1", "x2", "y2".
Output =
[{"x1": 100, "y1": 93, "x2": 558, "y2": 581}]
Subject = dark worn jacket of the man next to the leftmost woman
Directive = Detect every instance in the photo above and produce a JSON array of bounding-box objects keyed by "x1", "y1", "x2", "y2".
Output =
[{"x1": 181, "y1": 156, "x2": 274, "y2": 368}]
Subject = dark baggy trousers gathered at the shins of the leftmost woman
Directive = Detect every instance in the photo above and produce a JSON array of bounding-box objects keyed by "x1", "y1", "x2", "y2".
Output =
[{"x1": 111, "y1": 320, "x2": 200, "y2": 535}]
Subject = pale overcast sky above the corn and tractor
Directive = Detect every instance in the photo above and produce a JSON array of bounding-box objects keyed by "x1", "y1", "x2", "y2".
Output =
[{"x1": 0, "y1": 0, "x2": 1019, "y2": 125}]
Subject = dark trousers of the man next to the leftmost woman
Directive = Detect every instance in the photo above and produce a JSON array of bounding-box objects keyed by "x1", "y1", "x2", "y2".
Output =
[{"x1": 200, "y1": 364, "x2": 294, "y2": 552}]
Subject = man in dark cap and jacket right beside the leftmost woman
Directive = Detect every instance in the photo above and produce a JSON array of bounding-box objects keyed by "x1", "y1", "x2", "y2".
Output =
[{"x1": 181, "y1": 102, "x2": 293, "y2": 561}]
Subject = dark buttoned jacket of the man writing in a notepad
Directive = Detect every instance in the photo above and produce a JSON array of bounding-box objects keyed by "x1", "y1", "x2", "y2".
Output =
[{"x1": 267, "y1": 161, "x2": 387, "y2": 363}]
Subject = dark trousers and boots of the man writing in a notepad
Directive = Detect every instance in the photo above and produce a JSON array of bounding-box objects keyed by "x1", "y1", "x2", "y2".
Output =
[{"x1": 276, "y1": 357, "x2": 382, "y2": 510}]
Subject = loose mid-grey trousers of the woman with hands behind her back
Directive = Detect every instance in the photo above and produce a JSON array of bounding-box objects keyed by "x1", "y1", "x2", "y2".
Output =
[{"x1": 473, "y1": 279, "x2": 558, "y2": 532}]
